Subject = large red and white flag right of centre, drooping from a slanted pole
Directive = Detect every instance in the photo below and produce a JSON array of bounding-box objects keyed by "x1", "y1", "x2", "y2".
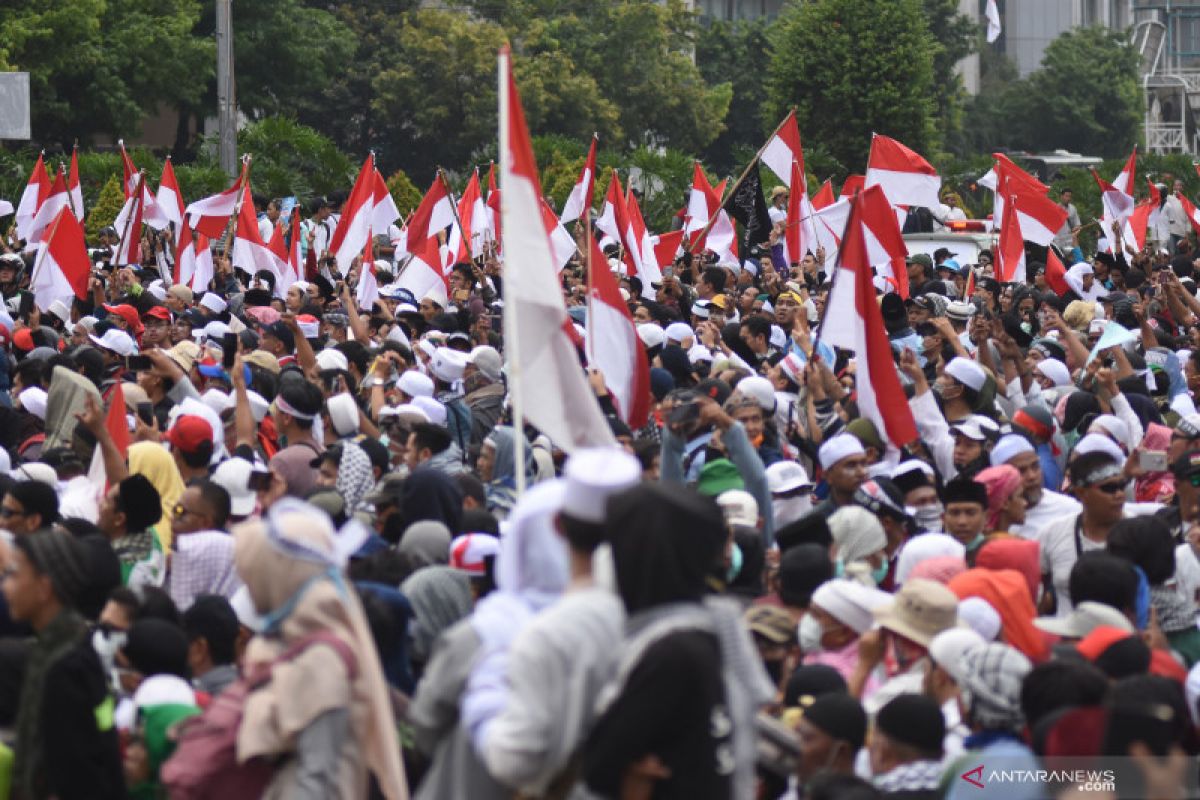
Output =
[{"x1": 820, "y1": 188, "x2": 917, "y2": 447}]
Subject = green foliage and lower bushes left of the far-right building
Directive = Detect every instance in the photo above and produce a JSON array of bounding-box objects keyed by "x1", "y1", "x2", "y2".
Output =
[{"x1": 956, "y1": 28, "x2": 1144, "y2": 157}]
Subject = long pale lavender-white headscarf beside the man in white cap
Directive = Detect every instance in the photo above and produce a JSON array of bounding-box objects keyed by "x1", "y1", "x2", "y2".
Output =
[{"x1": 461, "y1": 480, "x2": 571, "y2": 752}]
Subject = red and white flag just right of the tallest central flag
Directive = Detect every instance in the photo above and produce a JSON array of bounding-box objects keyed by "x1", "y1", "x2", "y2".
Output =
[{"x1": 586, "y1": 237, "x2": 650, "y2": 431}]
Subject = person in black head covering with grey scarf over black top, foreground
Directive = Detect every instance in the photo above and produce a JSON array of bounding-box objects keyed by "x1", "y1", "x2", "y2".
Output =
[{"x1": 583, "y1": 483, "x2": 774, "y2": 800}]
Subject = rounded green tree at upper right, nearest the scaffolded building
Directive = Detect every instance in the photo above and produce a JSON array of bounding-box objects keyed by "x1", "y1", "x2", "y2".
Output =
[{"x1": 1015, "y1": 26, "x2": 1144, "y2": 157}]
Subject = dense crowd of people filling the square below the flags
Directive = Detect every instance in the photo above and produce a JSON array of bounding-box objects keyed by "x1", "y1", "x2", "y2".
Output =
[{"x1": 0, "y1": 179, "x2": 1200, "y2": 800}]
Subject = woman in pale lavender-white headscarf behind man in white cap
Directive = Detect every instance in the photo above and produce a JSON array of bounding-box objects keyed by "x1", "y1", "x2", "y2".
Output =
[{"x1": 409, "y1": 481, "x2": 570, "y2": 800}]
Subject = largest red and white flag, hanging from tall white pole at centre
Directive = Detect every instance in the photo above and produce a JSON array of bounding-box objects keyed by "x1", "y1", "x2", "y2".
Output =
[{"x1": 499, "y1": 47, "x2": 616, "y2": 452}]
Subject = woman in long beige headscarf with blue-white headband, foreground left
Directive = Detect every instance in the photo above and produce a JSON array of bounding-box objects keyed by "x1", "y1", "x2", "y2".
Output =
[{"x1": 234, "y1": 499, "x2": 408, "y2": 800}]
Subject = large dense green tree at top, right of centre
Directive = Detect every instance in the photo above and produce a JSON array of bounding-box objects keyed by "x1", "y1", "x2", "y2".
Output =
[{"x1": 767, "y1": 0, "x2": 938, "y2": 172}]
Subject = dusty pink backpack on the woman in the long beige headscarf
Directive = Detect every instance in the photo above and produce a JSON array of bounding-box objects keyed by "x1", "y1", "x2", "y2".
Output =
[{"x1": 160, "y1": 631, "x2": 358, "y2": 800}]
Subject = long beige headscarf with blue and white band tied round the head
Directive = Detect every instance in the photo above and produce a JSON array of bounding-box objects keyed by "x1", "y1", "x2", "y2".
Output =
[{"x1": 234, "y1": 501, "x2": 408, "y2": 800}]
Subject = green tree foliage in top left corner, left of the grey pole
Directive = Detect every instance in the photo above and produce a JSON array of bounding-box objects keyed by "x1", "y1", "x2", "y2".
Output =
[{"x1": 0, "y1": 0, "x2": 214, "y2": 148}]
